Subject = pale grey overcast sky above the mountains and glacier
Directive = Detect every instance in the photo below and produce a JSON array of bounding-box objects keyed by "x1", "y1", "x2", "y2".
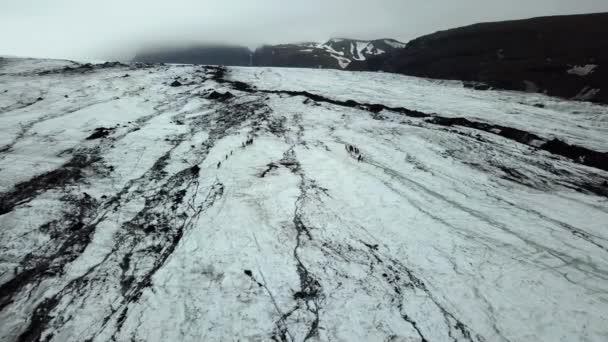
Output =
[{"x1": 0, "y1": 0, "x2": 608, "y2": 59}]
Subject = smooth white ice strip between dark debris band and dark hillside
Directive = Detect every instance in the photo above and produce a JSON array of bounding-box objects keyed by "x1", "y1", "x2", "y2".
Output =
[{"x1": 233, "y1": 68, "x2": 608, "y2": 152}]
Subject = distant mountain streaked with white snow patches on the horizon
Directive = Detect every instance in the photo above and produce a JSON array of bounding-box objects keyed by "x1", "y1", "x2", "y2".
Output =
[{"x1": 254, "y1": 38, "x2": 405, "y2": 69}]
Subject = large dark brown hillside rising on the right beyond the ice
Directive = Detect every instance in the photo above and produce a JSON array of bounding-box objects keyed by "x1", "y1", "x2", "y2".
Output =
[{"x1": 360, "y1": 13, "x2": 608, "y2": 103}]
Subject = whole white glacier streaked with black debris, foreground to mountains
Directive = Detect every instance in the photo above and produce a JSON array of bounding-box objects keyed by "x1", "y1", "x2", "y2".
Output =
[{"x1": 0, "y1": 59, "x2": 608, "y2": 342}]
